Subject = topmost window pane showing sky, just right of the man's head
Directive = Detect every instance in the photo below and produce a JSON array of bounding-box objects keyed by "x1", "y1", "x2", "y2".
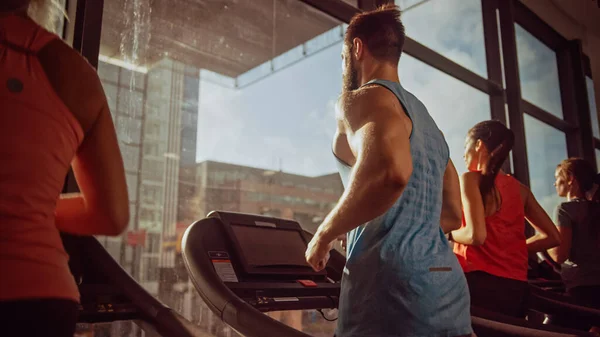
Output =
[{"x1": 395, "y1": 0, "x2": 487, "y2": 78}]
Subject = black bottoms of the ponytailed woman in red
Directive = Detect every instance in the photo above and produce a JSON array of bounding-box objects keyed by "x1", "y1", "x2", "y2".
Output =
[{"x1": 465, "y1": 271, "x2": 529, "y2": 318}]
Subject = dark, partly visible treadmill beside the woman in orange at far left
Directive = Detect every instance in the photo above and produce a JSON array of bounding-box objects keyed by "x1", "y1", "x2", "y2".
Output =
[{"x1": 61, "y1": 233, "x2": 208, "y2": 337}]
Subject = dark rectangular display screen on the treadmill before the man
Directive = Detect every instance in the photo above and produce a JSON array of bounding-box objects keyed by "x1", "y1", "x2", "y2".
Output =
[{"x1": 231, "y1": 224, "x2": 309, "y2": 267}]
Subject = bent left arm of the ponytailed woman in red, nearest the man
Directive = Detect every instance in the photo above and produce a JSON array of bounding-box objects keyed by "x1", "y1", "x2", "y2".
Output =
[{"x1": 452, "y1": 172, "x2": 487, "y2": 246}]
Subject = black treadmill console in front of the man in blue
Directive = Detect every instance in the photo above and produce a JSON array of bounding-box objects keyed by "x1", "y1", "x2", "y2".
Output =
[{"x1": 183, "y1": 211, "x2": 345, "y2": 311}]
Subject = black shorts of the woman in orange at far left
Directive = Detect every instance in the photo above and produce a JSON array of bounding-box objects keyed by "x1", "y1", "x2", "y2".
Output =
[{"x1": 0, "y1": 299, "x2": 78, "y2": 337}]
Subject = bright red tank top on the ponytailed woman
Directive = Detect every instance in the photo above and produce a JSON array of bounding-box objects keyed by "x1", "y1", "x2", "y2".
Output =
[{"x1": 454, "y1": 174, "x2": 528, "y2": 281}]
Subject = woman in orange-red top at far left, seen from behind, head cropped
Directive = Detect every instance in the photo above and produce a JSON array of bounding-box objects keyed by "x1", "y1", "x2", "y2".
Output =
[{"x1": 0, "y1": 0, "x2": 129, "y2": 336}]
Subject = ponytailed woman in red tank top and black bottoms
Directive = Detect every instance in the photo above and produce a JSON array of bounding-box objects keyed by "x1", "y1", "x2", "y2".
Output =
[{"x1": 450, "y1": 121, "x2": 560, "y2": 317}]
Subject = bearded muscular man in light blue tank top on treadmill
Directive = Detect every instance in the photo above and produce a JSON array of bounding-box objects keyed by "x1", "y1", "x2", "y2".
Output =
[{"x1": 306, "y1": 5, "x2": 472, "y2": 337}]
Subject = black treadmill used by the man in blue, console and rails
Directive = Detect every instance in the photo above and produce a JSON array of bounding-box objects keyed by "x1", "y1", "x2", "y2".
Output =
[{"x1": 182, "y1": 211, "x2": 593, "y2": 337}]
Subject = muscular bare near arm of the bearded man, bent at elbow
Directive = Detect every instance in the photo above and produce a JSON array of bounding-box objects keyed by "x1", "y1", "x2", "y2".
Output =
[{"x1": 307, "y1": 88, "x2": 412, "y2": 269}]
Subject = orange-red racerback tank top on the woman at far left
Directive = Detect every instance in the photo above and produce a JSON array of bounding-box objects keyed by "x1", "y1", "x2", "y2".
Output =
[{"x1": 0, "y1": 15, "x2": 83, "y2": 301}]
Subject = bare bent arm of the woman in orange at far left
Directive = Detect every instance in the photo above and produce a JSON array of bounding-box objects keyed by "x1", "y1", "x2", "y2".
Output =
[{"x1": 38, "y1": 39, "x2": 129, "y2": 235}]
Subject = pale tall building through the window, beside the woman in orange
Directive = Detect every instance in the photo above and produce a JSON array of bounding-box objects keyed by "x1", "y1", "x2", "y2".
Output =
[{"x1": 98, "y1": 58, "x2": 199, "y2": 295}]
